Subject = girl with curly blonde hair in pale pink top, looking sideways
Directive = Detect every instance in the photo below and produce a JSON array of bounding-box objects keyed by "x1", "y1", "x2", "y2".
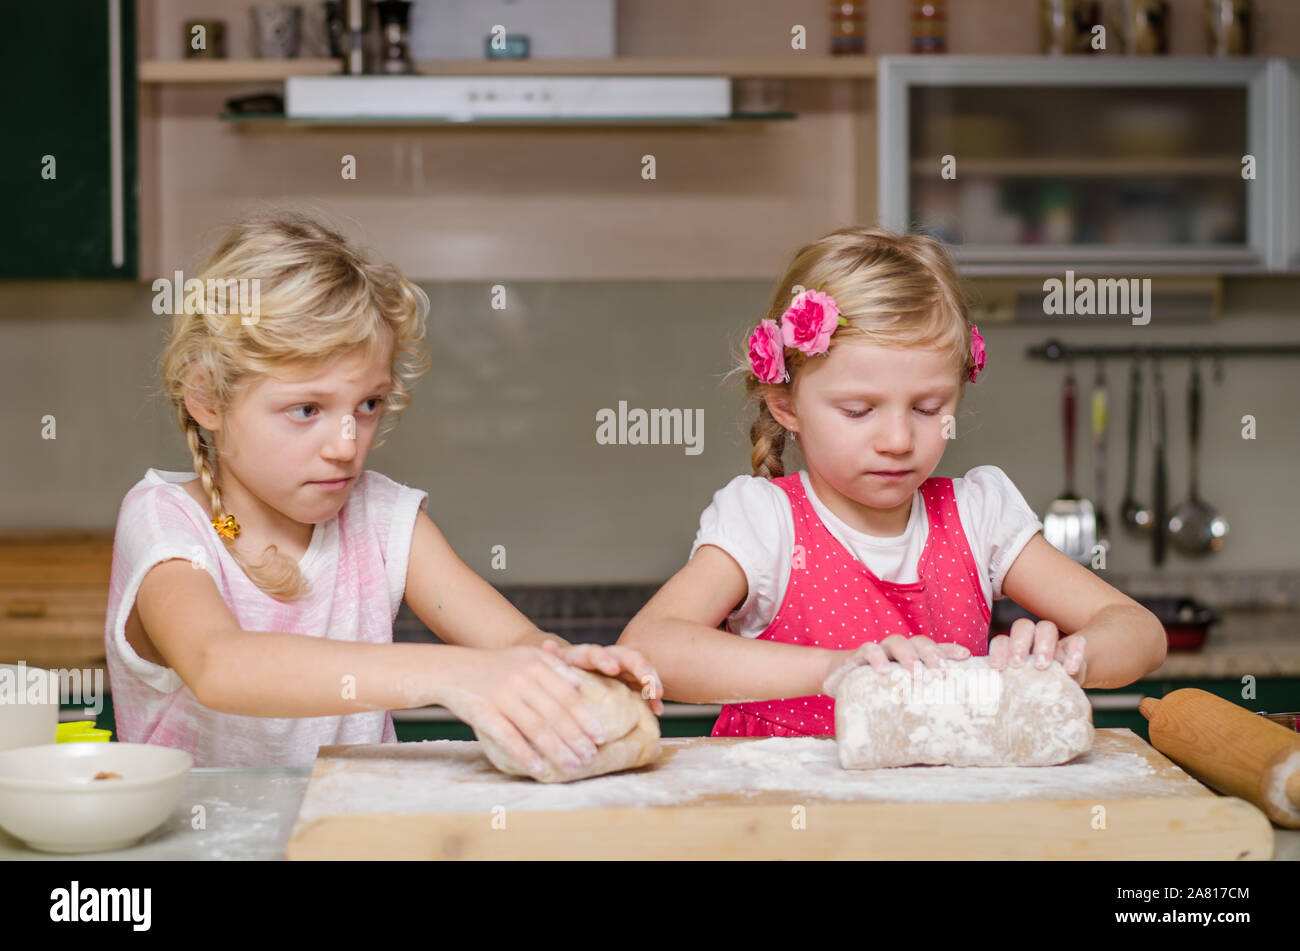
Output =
[{"x1": 105, "y1": 212, "x2": 662, "y2": 770}]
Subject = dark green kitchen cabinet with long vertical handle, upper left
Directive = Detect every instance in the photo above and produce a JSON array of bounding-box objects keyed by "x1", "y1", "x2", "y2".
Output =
[{"x1": 0, "y1": 0, "x2": 138, "y2": 279}]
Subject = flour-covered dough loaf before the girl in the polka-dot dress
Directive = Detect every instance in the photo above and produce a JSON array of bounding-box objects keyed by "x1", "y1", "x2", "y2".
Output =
[{"x1": 827, "y1": 657, "x2": 1093, "y2": 769}]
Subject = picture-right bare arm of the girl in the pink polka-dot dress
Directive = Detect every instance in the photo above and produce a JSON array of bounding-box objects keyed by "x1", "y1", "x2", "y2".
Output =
[{"x1": 1002, "y1": 533, "x2": 1169, "y2": 689}]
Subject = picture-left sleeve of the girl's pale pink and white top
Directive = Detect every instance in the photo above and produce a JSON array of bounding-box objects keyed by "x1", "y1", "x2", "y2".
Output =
[{"x1": 107, "y1": 488, "x2": 222, "y2": 694}]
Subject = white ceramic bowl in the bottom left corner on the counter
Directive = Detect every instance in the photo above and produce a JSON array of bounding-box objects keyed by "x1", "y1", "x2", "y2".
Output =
[{"x1": 0, "y1": 743, "x2": 194, "y2": 852}]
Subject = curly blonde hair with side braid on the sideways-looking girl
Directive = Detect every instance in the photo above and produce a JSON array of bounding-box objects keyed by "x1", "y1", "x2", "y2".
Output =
[{"x1": 163, "y1": 210, "x2": 429, "y2": 600}]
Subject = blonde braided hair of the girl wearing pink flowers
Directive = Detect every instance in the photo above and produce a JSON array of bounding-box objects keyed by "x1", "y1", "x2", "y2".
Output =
[{"x1": 732, "y1": 227, "x2": 972, "y2": 478}]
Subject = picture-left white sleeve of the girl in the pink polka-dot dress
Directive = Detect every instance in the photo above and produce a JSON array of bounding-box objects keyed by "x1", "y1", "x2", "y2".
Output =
[{"x1": 690, "y1": 476, "x2": 794, "y2": 637}]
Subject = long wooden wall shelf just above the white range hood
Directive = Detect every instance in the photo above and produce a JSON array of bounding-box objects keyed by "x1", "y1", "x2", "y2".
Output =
[{"x1": 139, "y1": 53, "x2": 876, "y2": 83}]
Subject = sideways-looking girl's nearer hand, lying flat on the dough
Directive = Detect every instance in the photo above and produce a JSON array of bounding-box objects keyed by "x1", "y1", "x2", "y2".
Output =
[{"x1": 438, "y1": 646, "x2": 606, "y2": 773}]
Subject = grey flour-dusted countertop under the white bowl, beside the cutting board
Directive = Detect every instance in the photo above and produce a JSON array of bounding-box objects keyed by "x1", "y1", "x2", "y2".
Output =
[{"x1": 0, "y1": 767, "x2": 1300, "y2": 861}]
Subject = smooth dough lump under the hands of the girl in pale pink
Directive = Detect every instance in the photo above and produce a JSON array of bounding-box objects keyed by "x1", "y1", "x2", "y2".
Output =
[{"x1": 475, "y1": 668, "x2": 659, "y2": 782}]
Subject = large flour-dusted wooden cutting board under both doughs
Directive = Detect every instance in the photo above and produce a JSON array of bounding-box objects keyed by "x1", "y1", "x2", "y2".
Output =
[{"x1": 286, "y1": 729, "x2": 1273, "y2": 860}]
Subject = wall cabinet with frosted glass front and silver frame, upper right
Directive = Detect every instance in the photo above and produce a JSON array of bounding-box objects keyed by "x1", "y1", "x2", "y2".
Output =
[{"x1": 878, "y1": 56, "x2": 1300, "y2": 274}]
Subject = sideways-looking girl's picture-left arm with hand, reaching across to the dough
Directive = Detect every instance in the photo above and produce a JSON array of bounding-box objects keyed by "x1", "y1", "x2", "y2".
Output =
[{"x1": 133, "y1": 559, "x2": 603, "y2": 769}]
